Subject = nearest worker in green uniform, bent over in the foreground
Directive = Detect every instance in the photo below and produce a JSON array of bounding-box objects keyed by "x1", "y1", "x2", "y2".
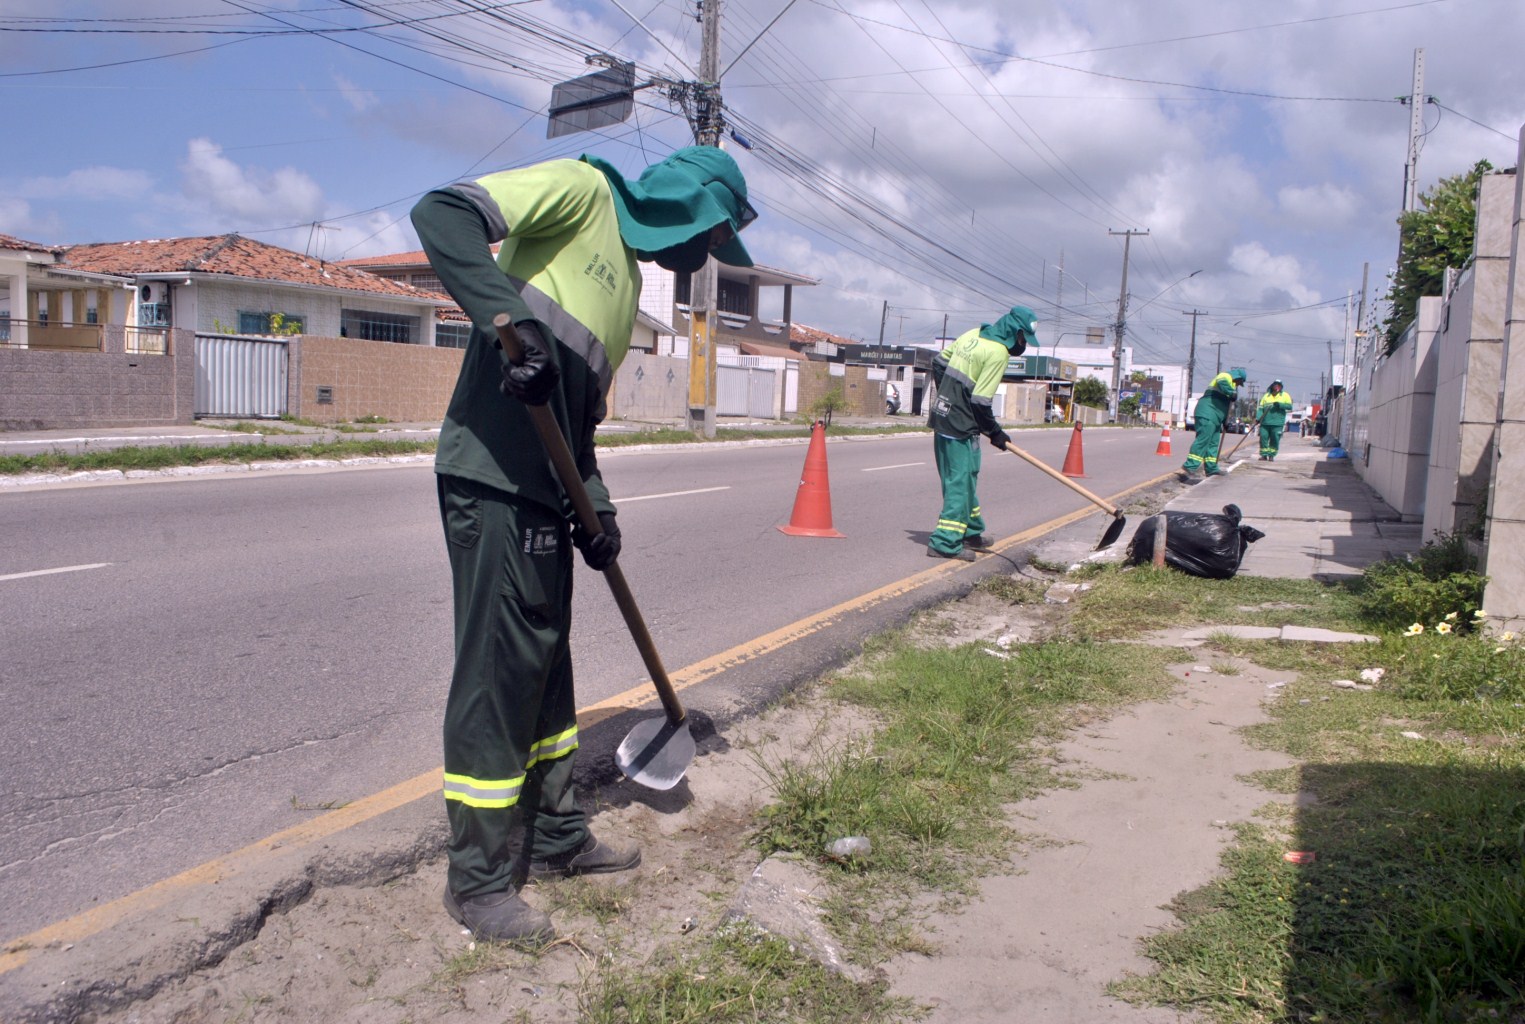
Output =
[{"x1": 413, "y1": 147, "x2": 756, "y2": 942}]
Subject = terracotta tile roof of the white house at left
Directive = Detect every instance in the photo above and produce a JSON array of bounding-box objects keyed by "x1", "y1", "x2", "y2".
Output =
[{"x1": 64, "y1": 233, "x2": 436, "y2": 304}]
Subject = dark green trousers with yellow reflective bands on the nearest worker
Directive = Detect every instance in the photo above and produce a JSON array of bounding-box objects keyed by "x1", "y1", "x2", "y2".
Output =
[{"x1": 436, "y1": 475, "x2": 587, "y2": 897}]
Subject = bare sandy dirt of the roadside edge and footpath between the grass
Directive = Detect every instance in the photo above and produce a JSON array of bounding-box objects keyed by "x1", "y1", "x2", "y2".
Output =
[{"x1": 92, "y1": 592, "x2": 1287, "y2": 1024}]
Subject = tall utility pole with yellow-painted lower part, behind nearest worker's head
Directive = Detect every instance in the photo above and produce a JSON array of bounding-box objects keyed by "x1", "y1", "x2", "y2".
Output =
[{"x1": 688, "y1": 0, "x2": 724, "y2": 438}]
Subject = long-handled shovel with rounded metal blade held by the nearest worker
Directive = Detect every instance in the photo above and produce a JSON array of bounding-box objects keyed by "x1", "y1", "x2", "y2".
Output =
[{"x1": 493, "y1": 313, "x2": 694, "y2": 789}]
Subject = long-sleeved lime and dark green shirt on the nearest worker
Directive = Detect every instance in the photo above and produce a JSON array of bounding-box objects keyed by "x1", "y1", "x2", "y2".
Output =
[{"x1": 413, "y1": 160, "x2": 641, "y2": 511}]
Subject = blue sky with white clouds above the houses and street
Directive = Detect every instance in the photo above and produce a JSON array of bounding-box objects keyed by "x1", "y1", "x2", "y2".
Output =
[{"x1": 0, "y1": 0, "x2": 1525, "y2": 401}]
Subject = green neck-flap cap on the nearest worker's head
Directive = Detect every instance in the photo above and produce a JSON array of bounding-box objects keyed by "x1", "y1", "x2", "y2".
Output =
[{"x1": 583, "y1": 147, "x2": 758, "y2": 267}]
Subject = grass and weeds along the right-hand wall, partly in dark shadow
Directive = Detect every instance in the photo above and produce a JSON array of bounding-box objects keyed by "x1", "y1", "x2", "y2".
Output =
[{"x1": 1110, "y1": 549, "x2": 1525, "y2": 1024}]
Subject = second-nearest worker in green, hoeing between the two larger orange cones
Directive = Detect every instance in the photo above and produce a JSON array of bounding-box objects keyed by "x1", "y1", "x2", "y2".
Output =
[{"x1": 927, "y1": 305, "x2": 1037, "y2": 562}]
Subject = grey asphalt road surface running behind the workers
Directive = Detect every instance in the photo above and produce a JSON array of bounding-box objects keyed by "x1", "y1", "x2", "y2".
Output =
[{"x1": 0, "y1": 430, "x2": 1177, "y2": 940}]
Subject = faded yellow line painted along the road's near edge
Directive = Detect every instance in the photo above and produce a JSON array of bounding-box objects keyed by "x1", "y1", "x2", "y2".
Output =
[{"x1": 0, "y1": 470, "x2": 1174, "y2": 974}]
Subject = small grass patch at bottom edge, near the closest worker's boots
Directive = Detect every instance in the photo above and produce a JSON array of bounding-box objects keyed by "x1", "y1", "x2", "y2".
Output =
[{"x1": 578, "y1": 925, "x2": 918, "y2": 1024}]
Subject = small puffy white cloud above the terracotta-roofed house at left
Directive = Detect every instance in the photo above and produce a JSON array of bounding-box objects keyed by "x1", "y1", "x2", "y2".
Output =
[{"x1": 180, "y1": 139, "x2": 323, "y2": 229}]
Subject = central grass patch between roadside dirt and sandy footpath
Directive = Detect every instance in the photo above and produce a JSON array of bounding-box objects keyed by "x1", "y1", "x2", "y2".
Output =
[{"x1": 756, "y1": 635, "x2": 1171, "y2": 940}]
